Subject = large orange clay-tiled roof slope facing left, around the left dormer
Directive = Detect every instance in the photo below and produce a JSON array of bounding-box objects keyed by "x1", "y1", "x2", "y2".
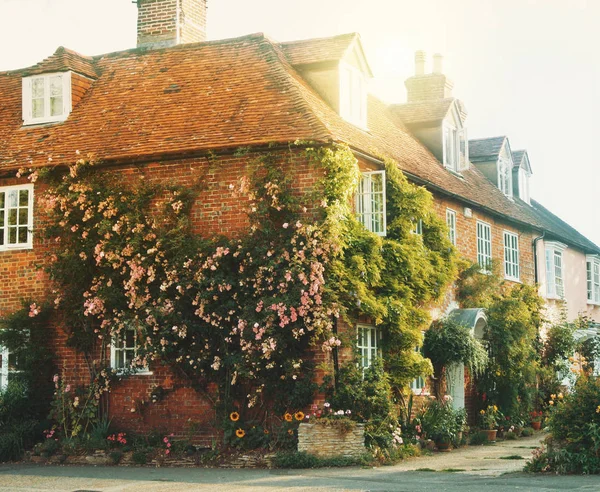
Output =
[{"x1": 0, "y1": 35, "x2": 330, "y2": 168}]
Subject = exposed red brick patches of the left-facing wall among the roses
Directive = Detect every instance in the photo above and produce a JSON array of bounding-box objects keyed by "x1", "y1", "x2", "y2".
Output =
[{"x1": 0, "y1": 152, "x2": 322, "y2": 445}]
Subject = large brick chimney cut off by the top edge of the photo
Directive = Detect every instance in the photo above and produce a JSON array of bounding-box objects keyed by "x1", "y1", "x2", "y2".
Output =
[{"x1": 137, "y1": 0, "x2": 207, "y2": 48}]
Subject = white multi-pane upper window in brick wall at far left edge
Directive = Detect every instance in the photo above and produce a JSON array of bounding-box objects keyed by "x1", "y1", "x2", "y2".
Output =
[{"x1": 0, "y1": 184, "x2": 33, "y2": 251}]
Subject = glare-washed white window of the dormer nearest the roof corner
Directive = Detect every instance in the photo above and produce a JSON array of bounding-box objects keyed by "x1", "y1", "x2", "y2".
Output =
[{"x1": 339, "y1": 62, "x2": 367, "y2": 128}]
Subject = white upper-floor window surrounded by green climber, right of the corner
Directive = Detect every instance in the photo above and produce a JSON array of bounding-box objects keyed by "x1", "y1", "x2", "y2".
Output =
[{"x1": 356, "y1": 171, "x2": 386, "y2": 236}]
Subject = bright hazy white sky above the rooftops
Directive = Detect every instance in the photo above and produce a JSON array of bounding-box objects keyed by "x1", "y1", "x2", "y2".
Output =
[{"x1": 0, "y1": 0, "x2": 600, "y2": 244}]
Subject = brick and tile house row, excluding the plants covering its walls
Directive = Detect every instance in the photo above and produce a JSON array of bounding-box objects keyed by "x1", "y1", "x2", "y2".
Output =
[{"x1": 0, "y1": 0, "x2": 600, "y2": 443}]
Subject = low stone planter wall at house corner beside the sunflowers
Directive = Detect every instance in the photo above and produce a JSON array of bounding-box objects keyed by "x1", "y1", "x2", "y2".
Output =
[{"x1": 298, "y1": 423, "x2": 365, "y2": 458}]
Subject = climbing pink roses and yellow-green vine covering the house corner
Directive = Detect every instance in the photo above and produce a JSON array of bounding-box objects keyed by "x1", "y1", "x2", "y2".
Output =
[{"x1": 14, "y1": 146, "x2": 455, "y2": 416}]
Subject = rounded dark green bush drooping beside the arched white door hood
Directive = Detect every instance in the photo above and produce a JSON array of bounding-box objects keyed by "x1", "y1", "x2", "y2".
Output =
[{"x1": 423, "y1": 319, "x2": 488, "y2": 398}]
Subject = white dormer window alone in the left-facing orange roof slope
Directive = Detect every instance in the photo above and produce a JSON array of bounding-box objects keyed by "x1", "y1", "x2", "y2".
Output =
[{"x1": 23, "y1": 72, "x2": 71, "y2": 125}]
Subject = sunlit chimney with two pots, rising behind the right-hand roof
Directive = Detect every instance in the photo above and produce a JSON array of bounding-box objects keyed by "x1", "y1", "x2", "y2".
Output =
[{"x1": 404, "y1": 51, "x2": 454, "y2": 102}]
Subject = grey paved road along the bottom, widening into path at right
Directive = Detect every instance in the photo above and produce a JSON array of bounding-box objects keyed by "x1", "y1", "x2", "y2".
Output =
[{"x1": 0, "y1": 439, "x2": 600, "y2": 492}]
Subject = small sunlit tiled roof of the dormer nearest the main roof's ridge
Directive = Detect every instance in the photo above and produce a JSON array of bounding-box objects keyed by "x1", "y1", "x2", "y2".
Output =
[{"x1": 279, "y1": 32, "x2": 358, "y2": 65}]
